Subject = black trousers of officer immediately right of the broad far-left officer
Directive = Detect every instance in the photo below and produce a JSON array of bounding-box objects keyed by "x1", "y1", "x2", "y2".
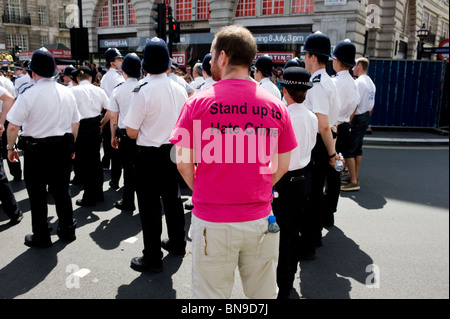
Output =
[{"x1": 75, "y1": 117, "x2": 103, "y2": 203}]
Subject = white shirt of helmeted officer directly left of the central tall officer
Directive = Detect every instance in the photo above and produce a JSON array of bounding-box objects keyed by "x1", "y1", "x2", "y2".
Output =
[{"x1": 106, "y1": 78, "x2": 139, "y2": 129}]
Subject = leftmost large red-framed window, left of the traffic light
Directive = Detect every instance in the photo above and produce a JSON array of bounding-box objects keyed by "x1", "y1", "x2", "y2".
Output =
[{"x1": 98, "y1": 0, "x2": 136, "y2": 27}]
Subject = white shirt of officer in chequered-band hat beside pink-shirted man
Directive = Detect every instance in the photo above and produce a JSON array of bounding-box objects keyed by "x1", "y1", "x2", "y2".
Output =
[{"x1": 288, "y1": 103, "x2": 319, "y2": 171}]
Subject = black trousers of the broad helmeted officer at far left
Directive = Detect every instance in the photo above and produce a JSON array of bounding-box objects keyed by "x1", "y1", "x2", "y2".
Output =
[{"x1": 24, "y1": 137, "x2": 73, "y2": 241}]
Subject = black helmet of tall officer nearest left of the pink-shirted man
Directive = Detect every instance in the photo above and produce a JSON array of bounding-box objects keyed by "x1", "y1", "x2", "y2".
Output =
[{"x1": 142, "y1": 37, "x2": 170, "y2": 74}]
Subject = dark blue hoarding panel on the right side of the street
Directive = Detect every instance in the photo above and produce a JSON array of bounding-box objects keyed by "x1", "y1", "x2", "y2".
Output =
[{"x1": 367, "y1": 59, "x2": 449, "y2": 128}]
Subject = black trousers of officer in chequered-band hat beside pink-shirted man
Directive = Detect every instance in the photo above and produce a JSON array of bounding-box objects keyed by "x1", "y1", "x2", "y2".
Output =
[{"x1": 272, "y1": 165, "x2": 315, "y2": 290}]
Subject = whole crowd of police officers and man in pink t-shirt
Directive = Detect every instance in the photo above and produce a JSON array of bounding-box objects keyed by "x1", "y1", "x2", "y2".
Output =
[{"x1": 0, "y1": 25, "x2": 375, "y2": 299}]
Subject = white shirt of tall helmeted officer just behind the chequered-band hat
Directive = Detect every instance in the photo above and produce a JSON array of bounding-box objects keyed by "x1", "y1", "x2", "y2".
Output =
[{"x1": 303, "y1": 69, "x2": 341, "y2": 127}]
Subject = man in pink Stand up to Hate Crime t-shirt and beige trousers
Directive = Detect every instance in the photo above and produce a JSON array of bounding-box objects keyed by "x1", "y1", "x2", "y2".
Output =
[{"x1": 171, "y1": 25, "x2": 297, "y2": 298}]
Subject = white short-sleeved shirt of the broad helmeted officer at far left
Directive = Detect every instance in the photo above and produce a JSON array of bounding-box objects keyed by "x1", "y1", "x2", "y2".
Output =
[{"x1": 6, "y1": 78, "x2": 80, "y2": 138}]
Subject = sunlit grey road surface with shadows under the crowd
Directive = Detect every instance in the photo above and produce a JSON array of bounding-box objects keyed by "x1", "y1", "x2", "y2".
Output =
[{"x1": 0, "y1": 145, "x2": 449, "y2": 299}]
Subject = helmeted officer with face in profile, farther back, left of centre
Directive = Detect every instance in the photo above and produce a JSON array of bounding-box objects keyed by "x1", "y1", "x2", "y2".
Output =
[{"x1": 100, "y1": 48, "x2": 125, "y2": 190}]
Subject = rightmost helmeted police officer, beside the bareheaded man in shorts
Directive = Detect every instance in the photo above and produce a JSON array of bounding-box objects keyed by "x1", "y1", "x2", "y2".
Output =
[{"x1": 324, "y1": 39, "x2": 359, "y2": 226}]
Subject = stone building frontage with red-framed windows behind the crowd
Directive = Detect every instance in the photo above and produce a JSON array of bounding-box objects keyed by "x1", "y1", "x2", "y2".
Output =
[{"x1": 0, "y1": 0, "x2": 449, "y2": 65}]
